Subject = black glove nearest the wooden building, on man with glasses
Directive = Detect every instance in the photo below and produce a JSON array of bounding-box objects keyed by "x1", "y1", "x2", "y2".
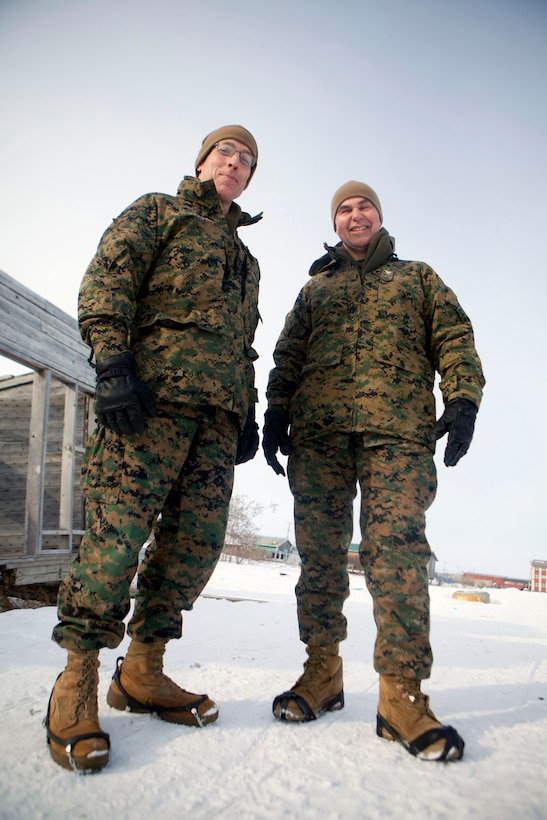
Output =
[{"x1": 95, "y1": 353, "x2": 156, "y2": 436}]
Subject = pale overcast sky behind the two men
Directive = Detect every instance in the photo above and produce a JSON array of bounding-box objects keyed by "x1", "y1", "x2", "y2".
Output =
[{"x1": 0, "y1": 0, "x2": 547, "y2": 578}]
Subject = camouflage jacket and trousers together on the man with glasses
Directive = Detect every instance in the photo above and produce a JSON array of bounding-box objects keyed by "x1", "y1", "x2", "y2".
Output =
[{"x1": 53, "y1": 177, "x2": 260, "y2": 650}]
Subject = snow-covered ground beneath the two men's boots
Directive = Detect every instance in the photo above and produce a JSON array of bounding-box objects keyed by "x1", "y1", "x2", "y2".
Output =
[{"x1": 0, "y1": 561, "x2": 547, "y2": 820}]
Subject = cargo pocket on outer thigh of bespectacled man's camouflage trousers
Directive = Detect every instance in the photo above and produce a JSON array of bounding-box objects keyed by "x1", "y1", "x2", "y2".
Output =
[{"x1": 81, "y1": 425, "x2": 125, "y2": 504}]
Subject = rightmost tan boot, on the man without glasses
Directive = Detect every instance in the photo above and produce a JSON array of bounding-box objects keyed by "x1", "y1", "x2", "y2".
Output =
[{"x1": 376, "y1": 675, "x2": 465, "y2": 760}]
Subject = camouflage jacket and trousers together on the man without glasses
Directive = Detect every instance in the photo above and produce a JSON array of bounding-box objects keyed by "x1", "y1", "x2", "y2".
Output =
[{"x1": 267, "y1": 228, "x2": 484, "y2": 679}]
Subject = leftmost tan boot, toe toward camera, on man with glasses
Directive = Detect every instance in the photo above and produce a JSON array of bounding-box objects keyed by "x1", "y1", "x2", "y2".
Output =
[{"x1": 44, "y1": 650, "x2": 110, "y2": 772}]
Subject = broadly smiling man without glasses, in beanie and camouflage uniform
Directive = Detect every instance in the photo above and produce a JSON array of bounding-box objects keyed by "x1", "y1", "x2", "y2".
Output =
[{"x1": 263, "y1": 180, "x2": 484, "y2": 760}]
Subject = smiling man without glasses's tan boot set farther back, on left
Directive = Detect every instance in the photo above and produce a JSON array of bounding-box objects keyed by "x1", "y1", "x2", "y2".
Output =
[{"x1": 272, "y1": 644, "x2": 344, "y2": 723}]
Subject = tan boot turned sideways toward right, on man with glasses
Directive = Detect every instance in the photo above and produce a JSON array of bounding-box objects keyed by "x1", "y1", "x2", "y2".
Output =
[{"x1": 106, "y1": 640, "x2": 218, "y2": 726}]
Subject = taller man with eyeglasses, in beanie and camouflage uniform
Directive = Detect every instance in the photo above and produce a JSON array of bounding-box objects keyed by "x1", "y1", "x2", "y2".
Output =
[{"x1": 46, "y1": 125, "x2": 262, "y2": 771}]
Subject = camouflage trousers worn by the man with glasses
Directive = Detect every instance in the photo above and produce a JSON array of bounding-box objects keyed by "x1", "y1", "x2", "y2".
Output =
[{"x1": 52, "y1": 407, "x2": 238, "y2": 650}]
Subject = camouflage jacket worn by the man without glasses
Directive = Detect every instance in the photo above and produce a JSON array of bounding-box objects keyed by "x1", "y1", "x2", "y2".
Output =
[{"x1": 267, "y1": 237, "x2": 484, "y2": 450}]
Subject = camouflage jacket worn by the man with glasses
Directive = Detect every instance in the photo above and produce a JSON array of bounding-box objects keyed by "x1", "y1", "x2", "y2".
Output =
[{"x1": 78, "y1": 177, "x2": 261, "y2": 422}]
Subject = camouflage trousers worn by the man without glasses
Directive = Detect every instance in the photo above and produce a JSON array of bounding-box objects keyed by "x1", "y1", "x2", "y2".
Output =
[{"x1": 288, "y1": 434, "x2": 437, "y2": 679}]
